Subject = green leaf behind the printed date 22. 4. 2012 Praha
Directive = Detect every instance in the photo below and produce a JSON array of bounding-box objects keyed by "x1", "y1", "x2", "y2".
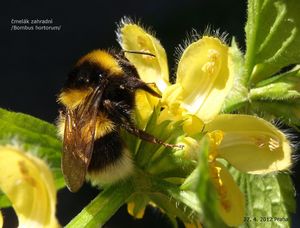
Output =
[{"x1": 230, "y1": 167, "x2": 295, "y2": 228}]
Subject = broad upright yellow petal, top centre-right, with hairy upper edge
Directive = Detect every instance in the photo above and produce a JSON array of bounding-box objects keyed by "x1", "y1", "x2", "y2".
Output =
[{"x1": 176, "y1": 36, "x2": 233, "y2": 122}]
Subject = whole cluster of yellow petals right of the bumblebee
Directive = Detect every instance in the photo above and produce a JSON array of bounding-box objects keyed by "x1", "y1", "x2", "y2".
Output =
[{"x1": 118, "y1": 20, "x2": 292, "y2": 226}]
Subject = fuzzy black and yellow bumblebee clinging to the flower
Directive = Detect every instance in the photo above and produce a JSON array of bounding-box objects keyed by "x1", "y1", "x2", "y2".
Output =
[{"x1": 57, "y1": 50, "x2": 175, "y2": 192}]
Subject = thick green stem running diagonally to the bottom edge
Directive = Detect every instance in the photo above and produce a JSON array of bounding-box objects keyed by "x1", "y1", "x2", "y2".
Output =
[{"x1": 66, "y1": 181, "x2": 133, "y2": 228}]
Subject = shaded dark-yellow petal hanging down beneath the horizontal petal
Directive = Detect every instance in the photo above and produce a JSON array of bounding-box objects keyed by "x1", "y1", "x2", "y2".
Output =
[{"x1": 210, "y1": 162, "x2": 245, "y2": 226}]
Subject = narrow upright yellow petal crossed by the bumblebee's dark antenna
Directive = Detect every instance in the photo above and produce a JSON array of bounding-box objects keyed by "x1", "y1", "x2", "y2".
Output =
[{"x1": 118, "y1": 23, "x2": 169, "y2": 92}]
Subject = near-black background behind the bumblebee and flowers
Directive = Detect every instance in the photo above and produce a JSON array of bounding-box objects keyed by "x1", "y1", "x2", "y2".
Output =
[{"x1": 0, "y1": 0, "x2": 300, "y2": 227}]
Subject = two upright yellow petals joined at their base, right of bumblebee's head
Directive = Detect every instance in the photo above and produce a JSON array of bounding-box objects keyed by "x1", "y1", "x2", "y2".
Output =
[{"x1": 119, "y1": 21, "x2": 233, "y2": 135}]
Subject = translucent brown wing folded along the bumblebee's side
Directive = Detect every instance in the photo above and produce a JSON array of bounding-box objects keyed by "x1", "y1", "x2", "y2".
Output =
[{"x1": 62, "y1": 83, "x2": 104, "y2": 192}]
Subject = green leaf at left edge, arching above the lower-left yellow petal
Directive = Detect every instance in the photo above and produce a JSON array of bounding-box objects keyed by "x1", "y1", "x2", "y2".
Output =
[{"x1": 0, "y1": 109, "x2": 65, "y2": 189}]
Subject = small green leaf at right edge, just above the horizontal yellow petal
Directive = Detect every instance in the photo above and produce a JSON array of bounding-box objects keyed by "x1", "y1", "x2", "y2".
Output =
[{"x1": 249, "y1": 67, "x2": 300, "y2": 128}]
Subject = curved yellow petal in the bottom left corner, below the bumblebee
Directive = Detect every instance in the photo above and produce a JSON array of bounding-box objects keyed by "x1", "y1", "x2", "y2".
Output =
[{"x1": 0, "y1": 146, "x2": 59, "y2": 227}]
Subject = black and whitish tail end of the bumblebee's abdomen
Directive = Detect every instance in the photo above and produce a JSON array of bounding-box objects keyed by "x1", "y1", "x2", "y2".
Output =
[{"x1": 87, "y1": 131, "x2": 133, "y2": 185}]
